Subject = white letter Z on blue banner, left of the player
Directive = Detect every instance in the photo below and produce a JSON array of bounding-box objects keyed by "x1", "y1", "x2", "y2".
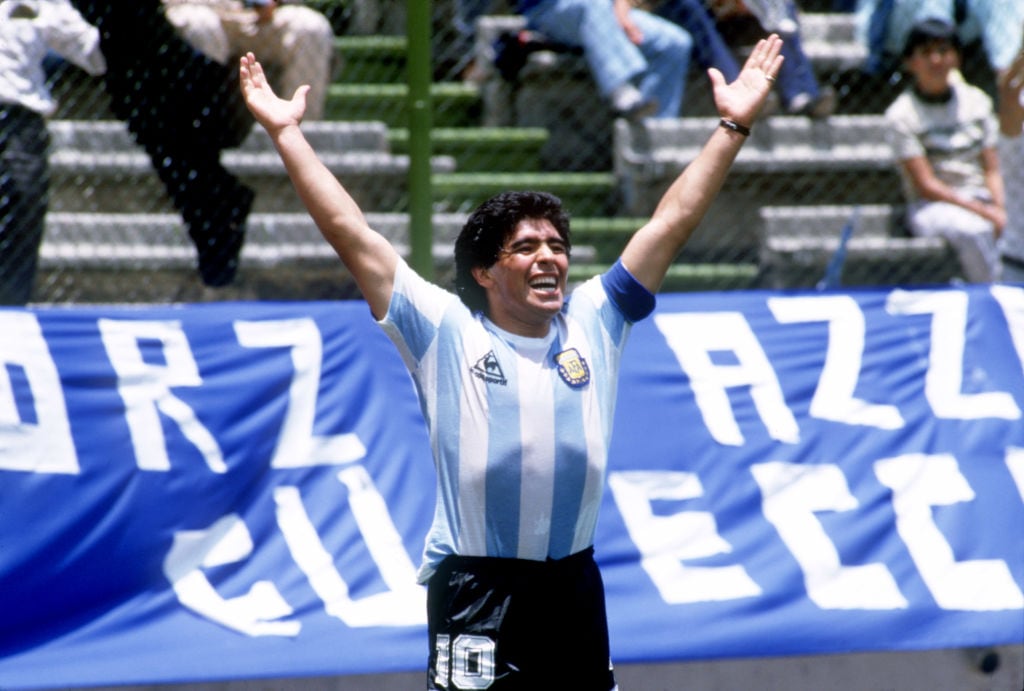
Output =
[{"x1": 234, "y1": 318, "x2": 367, "y2": 468}]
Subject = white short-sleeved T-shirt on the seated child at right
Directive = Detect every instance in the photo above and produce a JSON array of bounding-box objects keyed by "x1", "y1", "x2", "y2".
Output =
[{"x1": 886, "y1": 80, "x2": 997, "y2": 202}]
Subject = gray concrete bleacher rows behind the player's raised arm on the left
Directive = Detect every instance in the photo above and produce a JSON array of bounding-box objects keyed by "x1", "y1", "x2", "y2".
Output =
[{"x1": 39, "y1": 120, "x2": 462, "y2": 301}]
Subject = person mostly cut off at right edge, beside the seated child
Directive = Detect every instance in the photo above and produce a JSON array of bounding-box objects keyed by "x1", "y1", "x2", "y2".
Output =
[{"x1": 998, "y1": 37, "x2": 1024, "y2": 284}]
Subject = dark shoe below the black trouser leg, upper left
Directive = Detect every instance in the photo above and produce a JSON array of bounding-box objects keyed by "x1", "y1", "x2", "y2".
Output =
[{"x1": 188, "y1": 187, "x2": 255, "y2": 288}]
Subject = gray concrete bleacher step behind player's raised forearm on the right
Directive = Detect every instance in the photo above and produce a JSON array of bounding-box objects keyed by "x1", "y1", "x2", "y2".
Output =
[{"x1": 614, "y1": 116, "x2": 902, "y2": 261}]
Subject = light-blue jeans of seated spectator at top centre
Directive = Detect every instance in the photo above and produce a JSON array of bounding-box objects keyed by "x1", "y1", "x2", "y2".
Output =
[{"x1": 524, "y1": 0, "x2": 693, "y2": 118}]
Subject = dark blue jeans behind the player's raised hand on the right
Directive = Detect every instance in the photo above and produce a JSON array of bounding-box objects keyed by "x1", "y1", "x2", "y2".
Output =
[{"x1": 656, "y1": 0, "x2": 820, "y2": 106}]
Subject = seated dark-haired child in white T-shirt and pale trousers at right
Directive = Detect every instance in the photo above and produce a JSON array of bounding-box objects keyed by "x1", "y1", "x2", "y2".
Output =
[{"x1": 885, "y1": 18, "x2": 1007, "y2": 283}]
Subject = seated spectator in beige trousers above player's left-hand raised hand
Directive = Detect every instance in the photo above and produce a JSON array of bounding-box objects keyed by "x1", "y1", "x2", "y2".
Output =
[{"x1": 163, "y1": 0, "x2": 334, "y2": 120}]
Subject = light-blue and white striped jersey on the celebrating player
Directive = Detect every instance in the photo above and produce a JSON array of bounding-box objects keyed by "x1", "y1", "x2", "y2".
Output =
[{"x1": 381, "y1": 256, "x2": 653, "y2": 582}]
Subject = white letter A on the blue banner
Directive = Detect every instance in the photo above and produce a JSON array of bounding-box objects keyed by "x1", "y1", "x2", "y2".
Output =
[{"x1": 654, "y1": 312, "x2": 800, "y2": 446}]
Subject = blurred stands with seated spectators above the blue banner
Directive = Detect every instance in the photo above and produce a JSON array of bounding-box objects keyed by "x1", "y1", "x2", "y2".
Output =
[{"x1": 0, "y1": 0, "x2": 1024, "y2": 305}]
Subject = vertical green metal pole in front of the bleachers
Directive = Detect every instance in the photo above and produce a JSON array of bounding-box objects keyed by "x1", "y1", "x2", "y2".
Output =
[{"x1": 406, "y1": 0, "x2": 434, "y2": 279}]
